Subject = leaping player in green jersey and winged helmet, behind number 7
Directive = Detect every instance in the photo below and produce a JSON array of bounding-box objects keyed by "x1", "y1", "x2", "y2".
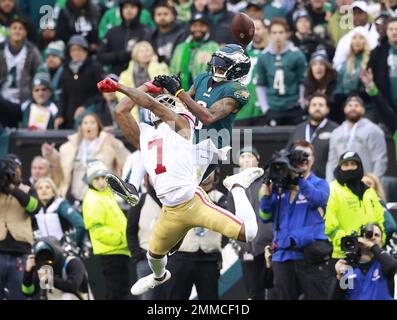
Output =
[{"x1": 107, "y1": 44, "x2": 251, "y2": 205}]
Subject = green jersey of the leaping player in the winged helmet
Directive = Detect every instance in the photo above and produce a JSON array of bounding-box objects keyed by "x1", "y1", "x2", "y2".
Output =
[{"x1": 193, "y1": 72, "x2": 249, "y2": 148}]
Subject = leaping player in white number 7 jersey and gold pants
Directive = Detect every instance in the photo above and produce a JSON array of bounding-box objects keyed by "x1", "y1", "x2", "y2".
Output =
[{"x1": 98, "y1": 78, "x2": 263, "y2": 295}]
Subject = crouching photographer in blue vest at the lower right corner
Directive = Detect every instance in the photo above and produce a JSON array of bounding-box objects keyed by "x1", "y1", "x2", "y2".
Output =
[{"x1": 332, "y1": 224, "x2": 397, "y2": 300}]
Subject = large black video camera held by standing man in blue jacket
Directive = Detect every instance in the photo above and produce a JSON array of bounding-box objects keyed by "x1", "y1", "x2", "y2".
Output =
[{"x1": 264, "y1": 149, "x2": 309, "y2": 186}]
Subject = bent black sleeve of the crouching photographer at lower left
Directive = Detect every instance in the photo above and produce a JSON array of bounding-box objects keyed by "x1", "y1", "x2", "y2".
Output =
[{"x1": 54, "y1": 259, "x2": 85, "y2": 293}]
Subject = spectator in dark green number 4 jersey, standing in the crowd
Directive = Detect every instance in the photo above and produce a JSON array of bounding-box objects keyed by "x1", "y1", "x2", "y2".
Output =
[{"x1": 256, "y1": 18, "x2": 307, "y2": 126}]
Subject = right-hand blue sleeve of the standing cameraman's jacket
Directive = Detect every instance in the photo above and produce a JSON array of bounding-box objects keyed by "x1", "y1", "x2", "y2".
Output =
[{"x1": 299, "y1": 178, "x2": 329, "y2": 209}]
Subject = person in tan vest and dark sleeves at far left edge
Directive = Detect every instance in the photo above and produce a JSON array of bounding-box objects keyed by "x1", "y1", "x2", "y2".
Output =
[{"x1": 0, "y1": 154, "x2": 41, "y2": 300}]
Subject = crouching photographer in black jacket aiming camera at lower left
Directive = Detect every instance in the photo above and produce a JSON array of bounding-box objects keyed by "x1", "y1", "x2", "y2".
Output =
[{"x1": 22, "y1": 237, "x2": 92, "y2": 300}]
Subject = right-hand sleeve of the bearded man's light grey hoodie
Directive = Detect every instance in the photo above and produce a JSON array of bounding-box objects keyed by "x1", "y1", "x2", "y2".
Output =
[{"x1": 368, "y1": 128, "x2": 387, "y2": 177}]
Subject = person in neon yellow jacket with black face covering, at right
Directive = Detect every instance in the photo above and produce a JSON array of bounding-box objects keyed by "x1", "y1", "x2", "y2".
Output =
[{"x1": 325, "y1": 151, "x2": 385, "y2": 259}]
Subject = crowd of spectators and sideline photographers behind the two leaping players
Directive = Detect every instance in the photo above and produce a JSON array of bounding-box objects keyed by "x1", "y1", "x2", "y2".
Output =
[{"x1": 0, "y1": 0, "x2": 397, "y2": 299}]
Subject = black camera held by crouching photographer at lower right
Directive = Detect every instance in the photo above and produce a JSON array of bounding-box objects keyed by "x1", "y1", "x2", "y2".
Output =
[{"x1": 340, "y1": 223, "x2": 374, "y2": 265}]
